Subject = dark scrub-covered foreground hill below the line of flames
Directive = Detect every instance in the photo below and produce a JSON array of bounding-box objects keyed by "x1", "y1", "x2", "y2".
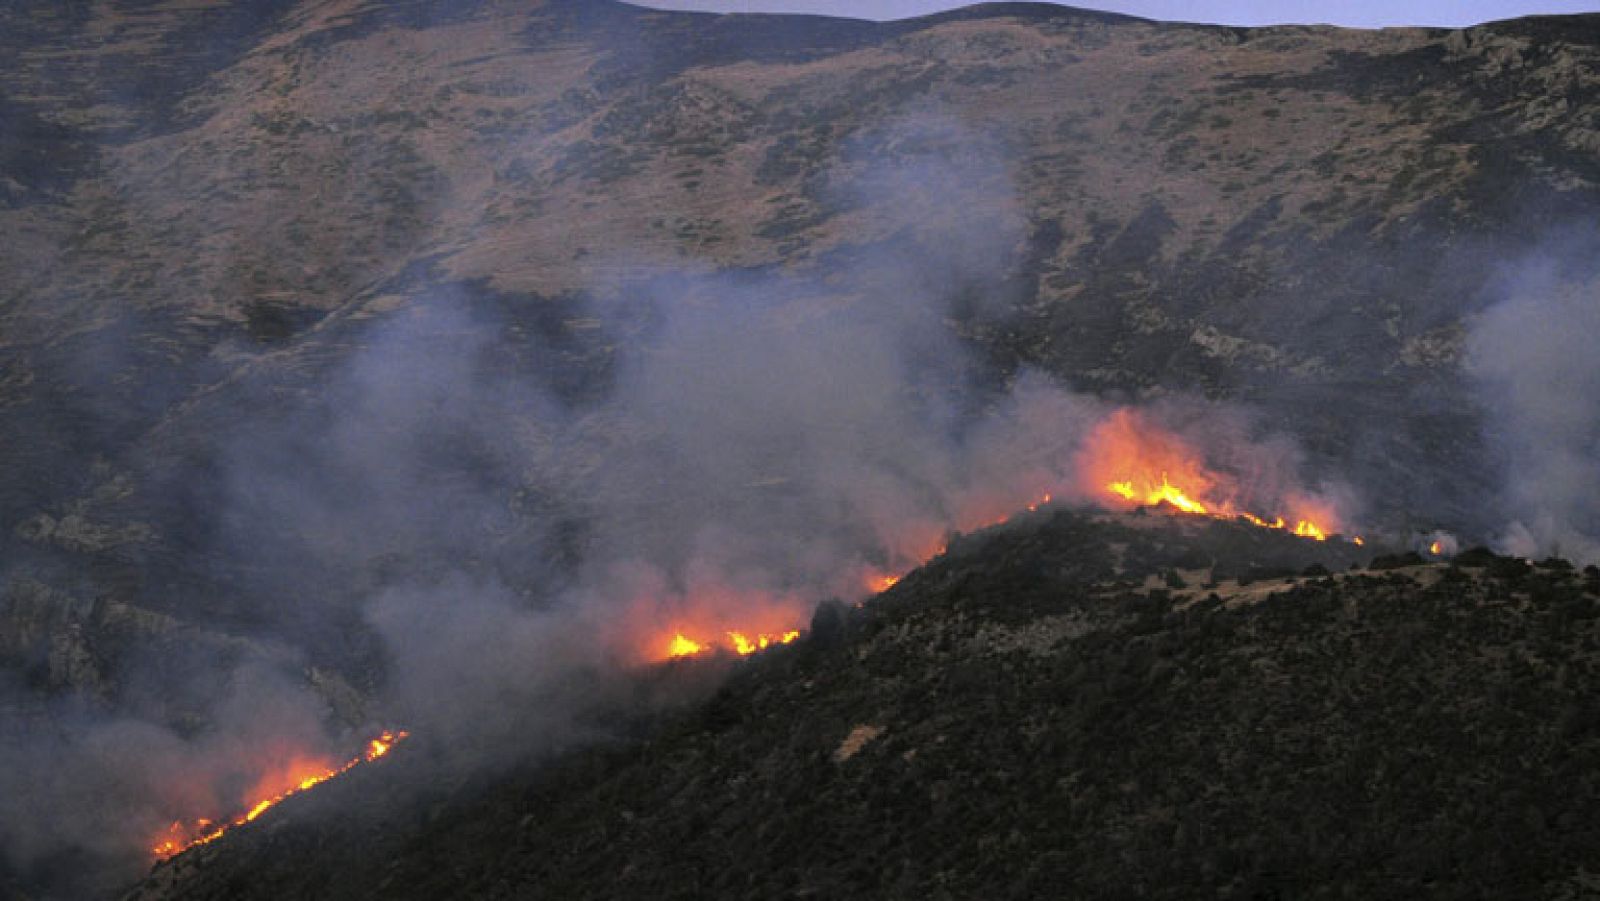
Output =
[{"x1": 133, "y1": 509, "x2": 1600, "y2": 898}]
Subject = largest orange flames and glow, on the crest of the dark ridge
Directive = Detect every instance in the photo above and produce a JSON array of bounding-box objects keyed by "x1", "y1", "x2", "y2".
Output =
[{"x1": 1077, "y1": 408, "x2": 1338, "y2": 541}]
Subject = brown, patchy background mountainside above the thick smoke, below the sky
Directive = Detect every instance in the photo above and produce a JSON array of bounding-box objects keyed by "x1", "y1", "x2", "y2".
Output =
[{"x1": 12, "y1": 2, "x2": 1600, "y2": 697}]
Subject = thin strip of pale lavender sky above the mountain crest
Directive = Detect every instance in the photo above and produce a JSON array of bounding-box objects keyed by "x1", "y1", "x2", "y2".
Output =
[{"x1": 630, "y1": 0, "x2": 1600, "y2": 29}]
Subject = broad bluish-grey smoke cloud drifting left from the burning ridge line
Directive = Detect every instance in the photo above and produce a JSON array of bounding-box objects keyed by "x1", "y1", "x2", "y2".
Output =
[{"x1": 0, "y1": 117, "x2": 1363, "y2": 896}]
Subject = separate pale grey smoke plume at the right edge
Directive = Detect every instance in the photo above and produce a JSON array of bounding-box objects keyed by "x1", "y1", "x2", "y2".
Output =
[{"x1": 1469, "y1": 267, "x2": 1600, "y2": 563}]
